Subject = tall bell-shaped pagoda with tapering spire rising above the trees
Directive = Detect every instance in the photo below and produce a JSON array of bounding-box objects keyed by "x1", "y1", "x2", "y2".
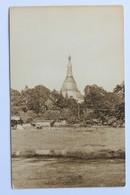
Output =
[{"x1": 61, "y1": 56, "x2": 83, "y2": 103}]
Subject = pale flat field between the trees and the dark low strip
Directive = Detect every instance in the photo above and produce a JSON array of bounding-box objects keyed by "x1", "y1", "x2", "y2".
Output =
[{"x1": 12, "y1": 127, "x2": 125, "y2": 156}]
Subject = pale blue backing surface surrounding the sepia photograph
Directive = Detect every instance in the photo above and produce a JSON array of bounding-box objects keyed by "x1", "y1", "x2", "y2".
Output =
[{"x1": 0, "y1": 0, "x2": 130, "y2": 195}]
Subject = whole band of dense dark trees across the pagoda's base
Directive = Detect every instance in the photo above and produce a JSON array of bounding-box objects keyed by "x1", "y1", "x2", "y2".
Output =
[{"x1": 11, "y1": 83, "x2": 125, "y2": 126}]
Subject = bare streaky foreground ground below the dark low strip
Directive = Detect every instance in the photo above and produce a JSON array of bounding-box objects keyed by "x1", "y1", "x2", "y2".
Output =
[{"x1": 12, "y1": 158, "x2": 125, "y2": 188}]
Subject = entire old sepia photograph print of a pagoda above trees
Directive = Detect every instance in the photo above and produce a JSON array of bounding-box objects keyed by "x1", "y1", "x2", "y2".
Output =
[{"x1": 10, "y1": 6, "x2": 126, "y2": 189}]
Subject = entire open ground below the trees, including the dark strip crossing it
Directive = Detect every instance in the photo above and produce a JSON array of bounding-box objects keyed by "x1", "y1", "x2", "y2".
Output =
[{"x1": 11, "y1": 127, "x2": 125, "y2": 188}]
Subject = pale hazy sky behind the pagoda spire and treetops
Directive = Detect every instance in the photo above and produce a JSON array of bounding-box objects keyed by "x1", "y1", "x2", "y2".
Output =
[{"x1": 10, "y1": 6, "x2": 124, "y2": 92}]
